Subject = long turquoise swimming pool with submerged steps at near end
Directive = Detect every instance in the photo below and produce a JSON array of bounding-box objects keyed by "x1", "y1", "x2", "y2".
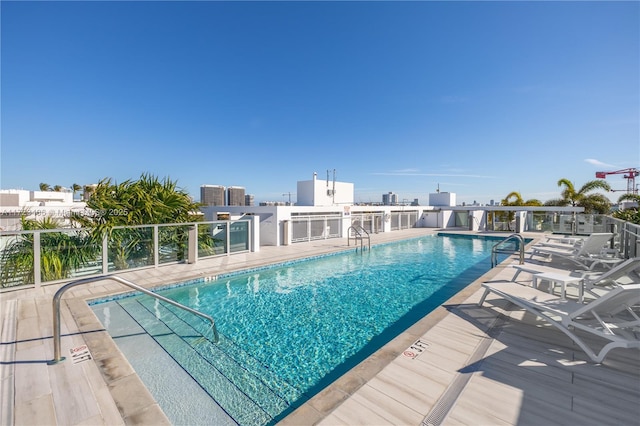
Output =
[{"x1": 92, "y1": 235, "x2": 508, "y2": 425}]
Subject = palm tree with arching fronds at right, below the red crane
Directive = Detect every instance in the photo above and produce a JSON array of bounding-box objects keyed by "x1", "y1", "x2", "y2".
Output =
[{"x1": 545, "y1": 178, "x2": 611, "y2": 214}]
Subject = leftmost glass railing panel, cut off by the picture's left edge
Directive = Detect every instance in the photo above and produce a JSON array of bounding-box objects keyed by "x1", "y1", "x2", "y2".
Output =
[{"x1": 0, "y1": 233, "x2": 35, "y2": 288}]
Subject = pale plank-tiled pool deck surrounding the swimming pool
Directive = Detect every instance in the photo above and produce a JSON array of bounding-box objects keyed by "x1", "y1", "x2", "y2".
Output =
[{"x1": 0, "y1": 228, "x2": 640, "y2": 426}]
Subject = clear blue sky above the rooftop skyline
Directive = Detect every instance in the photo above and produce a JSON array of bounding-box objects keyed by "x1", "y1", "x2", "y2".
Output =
[{"x1": 0, "y1": 1, "x2": 640, "y2": 204}]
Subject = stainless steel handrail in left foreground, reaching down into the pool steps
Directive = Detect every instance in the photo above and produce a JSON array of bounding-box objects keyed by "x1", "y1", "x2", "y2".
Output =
[{"x1": 48, "y1": 275, "x2": 220, "y2": 365}]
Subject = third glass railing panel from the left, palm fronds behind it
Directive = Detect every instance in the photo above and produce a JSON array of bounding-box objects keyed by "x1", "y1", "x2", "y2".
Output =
[{"x1": 108, "y1": 226, "x2": 154, "y2": 271}]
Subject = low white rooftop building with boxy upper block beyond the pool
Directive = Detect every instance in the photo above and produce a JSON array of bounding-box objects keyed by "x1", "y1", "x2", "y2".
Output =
[{"x1": 202, "y1": 173, "x2": 593, "y2": 247}]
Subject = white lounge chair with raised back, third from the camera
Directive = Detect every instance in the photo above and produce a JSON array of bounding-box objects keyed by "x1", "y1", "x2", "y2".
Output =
[{"x1": 531, "y1": 232, "x2": 624, "y2": 269}]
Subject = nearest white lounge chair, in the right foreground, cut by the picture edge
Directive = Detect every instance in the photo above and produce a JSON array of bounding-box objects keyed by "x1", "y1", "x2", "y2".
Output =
[{"x1": 478, "y1": 281, "x2": 640, "y2": 363}]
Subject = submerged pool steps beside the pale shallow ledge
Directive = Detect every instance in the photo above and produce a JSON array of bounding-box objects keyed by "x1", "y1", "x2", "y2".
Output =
[{"x1": 120, "y1": 299, "x2": 288, "y2": 425}]
